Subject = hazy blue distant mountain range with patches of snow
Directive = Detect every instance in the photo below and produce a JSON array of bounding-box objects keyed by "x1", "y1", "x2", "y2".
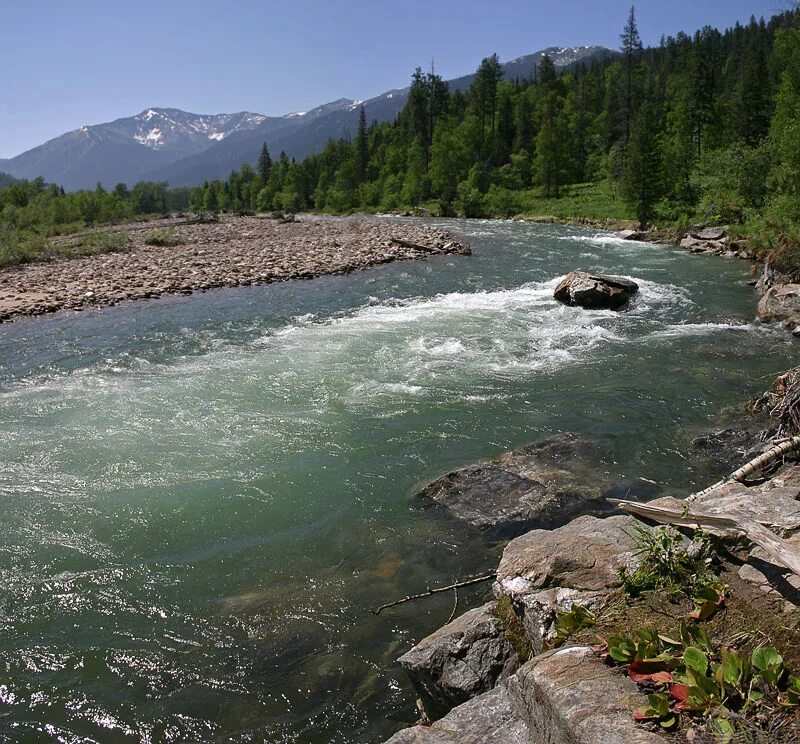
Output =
[{"x1": 0, "y1": 46, "x2": 614, "y2": 190}]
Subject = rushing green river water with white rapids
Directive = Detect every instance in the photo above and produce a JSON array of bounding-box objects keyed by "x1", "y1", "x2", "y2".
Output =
[{"x1": 0, "y1": 220, "x2": 797, "y2": 743}]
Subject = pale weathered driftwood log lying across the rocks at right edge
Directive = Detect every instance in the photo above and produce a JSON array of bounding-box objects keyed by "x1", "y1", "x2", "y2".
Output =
[{"x1": 609, "y1": 499, "x2": 800, "y2": 576}]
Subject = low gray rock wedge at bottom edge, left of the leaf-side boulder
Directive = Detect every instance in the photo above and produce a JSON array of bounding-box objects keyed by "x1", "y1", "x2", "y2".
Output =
[{"x1": 386, "y1": 685, "x2": 538, "y2": 744}]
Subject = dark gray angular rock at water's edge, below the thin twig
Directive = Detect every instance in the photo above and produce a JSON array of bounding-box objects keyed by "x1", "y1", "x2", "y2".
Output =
[{"x1": 398, "y1": 602, "x2": 519, "y2": 721}]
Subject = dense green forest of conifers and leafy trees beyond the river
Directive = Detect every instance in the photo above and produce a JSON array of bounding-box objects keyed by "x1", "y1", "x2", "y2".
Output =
[{"x1": 0, "y1": 8, "x2": 800, "y2": 262}]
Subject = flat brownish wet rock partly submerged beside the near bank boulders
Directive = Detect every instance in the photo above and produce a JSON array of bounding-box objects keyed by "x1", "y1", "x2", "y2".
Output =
[{"x1": 418, "y1": 433, "x2": 612, "y2": 540}]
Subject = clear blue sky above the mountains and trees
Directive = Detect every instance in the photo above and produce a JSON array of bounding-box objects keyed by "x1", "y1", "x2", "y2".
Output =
[{"x1": 0, "y1": 0, "x2": 791, "y2": 157}]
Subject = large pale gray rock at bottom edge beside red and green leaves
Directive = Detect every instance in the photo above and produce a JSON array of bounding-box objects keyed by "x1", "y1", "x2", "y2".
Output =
[{"x1": 507, "y1": 647, "x2": 665, "y2": 744}]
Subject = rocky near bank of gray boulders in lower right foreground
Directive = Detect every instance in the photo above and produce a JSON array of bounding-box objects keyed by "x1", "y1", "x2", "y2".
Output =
[{"x1": 382, "y1": 368, "x2": 800, "y2": 744}]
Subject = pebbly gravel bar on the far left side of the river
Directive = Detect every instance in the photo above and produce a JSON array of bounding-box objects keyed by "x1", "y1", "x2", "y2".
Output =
[{"x1": 0, "y1": 215, "x2": 470, "y2": 322}]
